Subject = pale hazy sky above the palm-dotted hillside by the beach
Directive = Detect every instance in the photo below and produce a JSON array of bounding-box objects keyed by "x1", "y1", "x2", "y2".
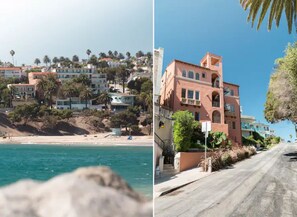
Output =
[{"x1": 0, "y1": 0, "x2": 153, "y2": 65}]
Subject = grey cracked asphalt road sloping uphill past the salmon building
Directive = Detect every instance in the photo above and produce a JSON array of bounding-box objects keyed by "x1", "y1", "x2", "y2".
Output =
[{"x1": 155, "y1": 144, "x2": 297, "y2": 217}]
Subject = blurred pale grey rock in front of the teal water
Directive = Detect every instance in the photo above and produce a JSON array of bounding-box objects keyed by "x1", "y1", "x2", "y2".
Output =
[{"x1": 0, "y1": 167, "x2": 153, "y2": 217}]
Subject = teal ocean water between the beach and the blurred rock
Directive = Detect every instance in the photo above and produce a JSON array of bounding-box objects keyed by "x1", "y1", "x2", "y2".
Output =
[{"x1": 0, "y1": 145, "x2": 153, "y2": 198}]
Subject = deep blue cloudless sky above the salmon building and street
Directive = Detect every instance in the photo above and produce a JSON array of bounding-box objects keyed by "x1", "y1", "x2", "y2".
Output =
[{"x1": 155, "y1": 0, "x2": 297, "y2": 139}]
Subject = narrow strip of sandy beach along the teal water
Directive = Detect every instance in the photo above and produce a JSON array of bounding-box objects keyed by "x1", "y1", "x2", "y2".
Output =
[{"x1": 0, "y1": 133, "x2": 153, "y2": 146}]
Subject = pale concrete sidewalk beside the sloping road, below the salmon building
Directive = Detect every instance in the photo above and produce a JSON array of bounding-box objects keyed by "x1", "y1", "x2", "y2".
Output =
[{"x1": 154, "y1": 167, "x2": 213, "y2": 198}]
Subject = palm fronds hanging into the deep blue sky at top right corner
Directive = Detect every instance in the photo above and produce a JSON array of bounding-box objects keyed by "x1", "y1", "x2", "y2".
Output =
[{"x1": 240, "y1": 0, "x2": 297, "y2": 33}]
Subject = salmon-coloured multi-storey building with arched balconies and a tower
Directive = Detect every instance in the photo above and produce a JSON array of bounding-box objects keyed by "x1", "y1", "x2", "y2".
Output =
[{"x1": 160, "y1": 53, "x2": 242, "y2": 144}]
